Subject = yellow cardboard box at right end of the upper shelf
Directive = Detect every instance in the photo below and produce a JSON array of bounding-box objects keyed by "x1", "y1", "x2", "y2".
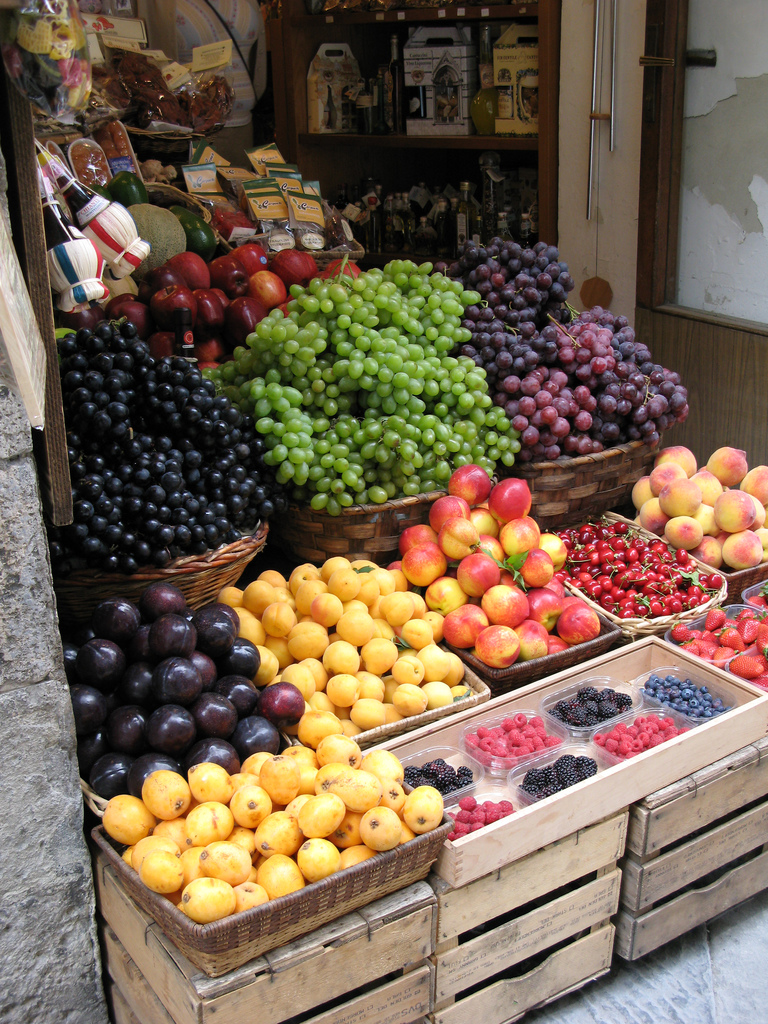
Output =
[{"x1": 494, "y1": 24, "x2": 539, "y2": 137}]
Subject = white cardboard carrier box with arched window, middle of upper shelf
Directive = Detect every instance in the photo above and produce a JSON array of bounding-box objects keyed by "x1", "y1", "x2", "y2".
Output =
[{"x1": 402, "y1": 26, "x2": 477, "y2": 135}]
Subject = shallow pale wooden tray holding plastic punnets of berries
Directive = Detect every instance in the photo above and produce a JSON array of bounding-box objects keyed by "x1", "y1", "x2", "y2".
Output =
[{"x1": 382, "y1": 637, "x2": 768, "y2": 886}]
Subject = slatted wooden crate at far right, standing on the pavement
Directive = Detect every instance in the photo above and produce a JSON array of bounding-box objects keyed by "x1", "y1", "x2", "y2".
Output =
[{"x1": 616, "y1": 738, "x2": 768, "y2": 959}]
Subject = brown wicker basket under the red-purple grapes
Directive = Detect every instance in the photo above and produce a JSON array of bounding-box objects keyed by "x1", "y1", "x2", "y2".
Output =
[{"x1": 507, "y1": 441, "x2": 658, "y2": 530}]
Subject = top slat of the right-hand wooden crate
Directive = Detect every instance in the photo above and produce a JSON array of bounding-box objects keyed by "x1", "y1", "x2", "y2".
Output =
[{"x1": 627, "y1": 738, "x2": 768, "y2": 858}]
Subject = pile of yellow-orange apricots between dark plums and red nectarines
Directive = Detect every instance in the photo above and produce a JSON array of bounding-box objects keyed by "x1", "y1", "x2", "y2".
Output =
[{"x1": 218, "y1": 557, "x2": 471, "y2": 748}]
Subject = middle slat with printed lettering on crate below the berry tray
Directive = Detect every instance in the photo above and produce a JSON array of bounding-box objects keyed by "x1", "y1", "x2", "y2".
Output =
[{"x1": 433, "y1": 869, "x2": 622, "y2": 1008}]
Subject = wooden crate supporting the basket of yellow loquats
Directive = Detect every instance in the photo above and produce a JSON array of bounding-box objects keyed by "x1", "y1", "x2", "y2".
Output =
[{"x1": 94, "y1": 854, "x2": 436, "y2": 1024}]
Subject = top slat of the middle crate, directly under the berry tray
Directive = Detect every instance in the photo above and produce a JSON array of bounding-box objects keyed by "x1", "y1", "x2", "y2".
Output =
[{"x1": 431, "y1": 812, "x2": 628, "y2": 950}]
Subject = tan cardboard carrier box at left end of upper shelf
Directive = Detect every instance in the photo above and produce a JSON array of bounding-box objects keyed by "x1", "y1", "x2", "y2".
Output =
[{"x1": 306, "y1": 43, "x2": 365, "y2": 135}]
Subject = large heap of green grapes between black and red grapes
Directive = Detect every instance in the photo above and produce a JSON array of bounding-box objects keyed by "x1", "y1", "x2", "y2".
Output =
[{"x1": 206, "y1": 260, "x2": 520, "y2": 515}]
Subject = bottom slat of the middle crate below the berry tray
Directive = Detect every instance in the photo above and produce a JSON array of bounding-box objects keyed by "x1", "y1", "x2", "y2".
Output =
[{"x1": 429, "y1": 925, "x2": 613, "y2": 1024}]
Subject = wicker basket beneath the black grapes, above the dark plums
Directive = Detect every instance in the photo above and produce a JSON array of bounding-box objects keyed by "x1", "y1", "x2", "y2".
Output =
[{"x1": 53, "y1": 523, "x2": 268, "y2": 626}]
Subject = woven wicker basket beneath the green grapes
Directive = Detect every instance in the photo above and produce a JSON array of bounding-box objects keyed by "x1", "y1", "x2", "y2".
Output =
[{"x1": 271, "y1": 490, "x2": 445, "y2": 565}]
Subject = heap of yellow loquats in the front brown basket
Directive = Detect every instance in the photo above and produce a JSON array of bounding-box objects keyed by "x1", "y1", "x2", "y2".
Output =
[{"x1": 103, "y1": 749, "x2": 442, "y2": 925}]
